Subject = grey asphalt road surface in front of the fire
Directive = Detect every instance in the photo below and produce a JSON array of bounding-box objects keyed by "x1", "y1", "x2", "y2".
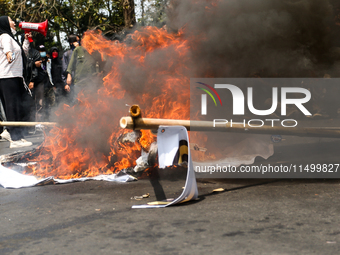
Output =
[{"x1": 0, "y1": 124, "x2": 340, "y2": 254}]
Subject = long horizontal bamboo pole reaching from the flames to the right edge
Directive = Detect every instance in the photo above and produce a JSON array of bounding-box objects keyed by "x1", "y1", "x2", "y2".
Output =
[{"x1": 120, "y1": 117, "x2": 340, "y2": 138}]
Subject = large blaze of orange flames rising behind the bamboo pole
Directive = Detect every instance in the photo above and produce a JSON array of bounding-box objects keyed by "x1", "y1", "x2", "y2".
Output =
[{"x1": 23, "y1": 24, "x2": 194, "y2": 179}]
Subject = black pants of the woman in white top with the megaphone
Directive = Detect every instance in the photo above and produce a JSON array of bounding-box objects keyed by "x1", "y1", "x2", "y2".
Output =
[{"x1": 0, "y1": 77, "x2": 25, "y2": 141}]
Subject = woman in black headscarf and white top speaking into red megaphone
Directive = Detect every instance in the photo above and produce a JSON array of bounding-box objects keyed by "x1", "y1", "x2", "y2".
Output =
[{"x1": 0, "y1": 16, "x2": 32, "y2": 148}]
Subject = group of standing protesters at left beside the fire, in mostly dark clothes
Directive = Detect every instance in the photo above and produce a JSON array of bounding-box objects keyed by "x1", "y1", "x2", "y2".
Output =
[{"x1": 0, "y1": 16, "x2": 98, "y2": 148}]
